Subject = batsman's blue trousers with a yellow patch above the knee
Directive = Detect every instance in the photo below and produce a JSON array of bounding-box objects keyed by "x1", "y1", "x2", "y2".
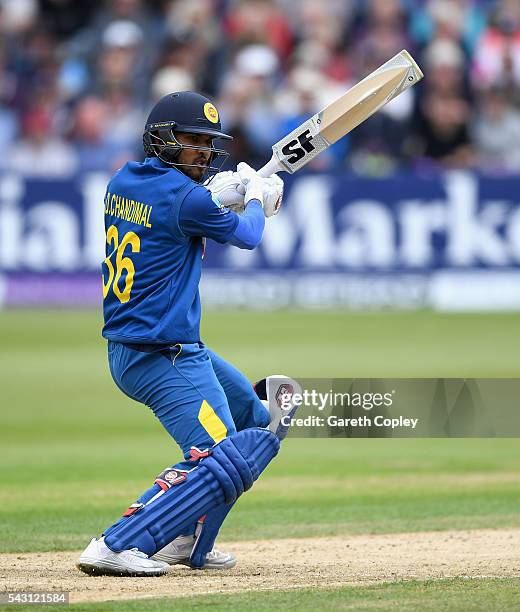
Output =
[{"x1": 104, "y1": 342, "x2": 269, "y2": 535}]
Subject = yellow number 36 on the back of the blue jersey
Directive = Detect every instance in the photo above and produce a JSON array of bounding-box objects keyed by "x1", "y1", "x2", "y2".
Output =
[{"x1": 103, "y1": 225, "x2": 141, "y2": 304}]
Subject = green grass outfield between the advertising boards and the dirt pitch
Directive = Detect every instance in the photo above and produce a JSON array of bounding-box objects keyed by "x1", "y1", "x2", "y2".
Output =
[{"x1": 0, "y1": 310, "x2": 520, "y2": 609}]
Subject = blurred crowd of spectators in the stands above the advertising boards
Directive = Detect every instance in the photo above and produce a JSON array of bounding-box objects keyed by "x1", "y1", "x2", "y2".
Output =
[{"x1": 0, "y1": 0, "x2": 520, "y2": 178}]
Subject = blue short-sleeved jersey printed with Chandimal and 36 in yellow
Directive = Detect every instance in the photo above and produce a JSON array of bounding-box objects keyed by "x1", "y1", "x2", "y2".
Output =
[{"x1": 102, "y1": 157, "x2": 239, "y2": 344}]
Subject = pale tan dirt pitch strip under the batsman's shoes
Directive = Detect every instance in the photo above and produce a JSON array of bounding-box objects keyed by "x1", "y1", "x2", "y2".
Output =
[{"x1": 0, "y1": 529, "x2": 520, "y2": 603}]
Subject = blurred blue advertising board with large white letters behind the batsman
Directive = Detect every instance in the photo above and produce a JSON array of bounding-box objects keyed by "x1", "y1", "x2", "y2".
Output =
[{"x1": 0, "y1": 172, "x2": 520, "y2": 309}]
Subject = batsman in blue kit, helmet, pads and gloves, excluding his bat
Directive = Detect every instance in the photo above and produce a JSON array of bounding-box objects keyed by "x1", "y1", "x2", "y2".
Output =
[{"x1": 78, "y1": 91, "x2": 294, "y2": 576}]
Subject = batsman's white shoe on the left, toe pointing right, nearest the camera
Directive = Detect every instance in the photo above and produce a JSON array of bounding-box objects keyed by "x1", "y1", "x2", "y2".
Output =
[{"x1": 76, "y1": 538, "x2": 170, "y2": 576}]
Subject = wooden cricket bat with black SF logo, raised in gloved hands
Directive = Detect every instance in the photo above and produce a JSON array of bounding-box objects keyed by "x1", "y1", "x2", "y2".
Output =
[{"x1": 215, "y1": 50, "x2": 424, "y2": 206}]
